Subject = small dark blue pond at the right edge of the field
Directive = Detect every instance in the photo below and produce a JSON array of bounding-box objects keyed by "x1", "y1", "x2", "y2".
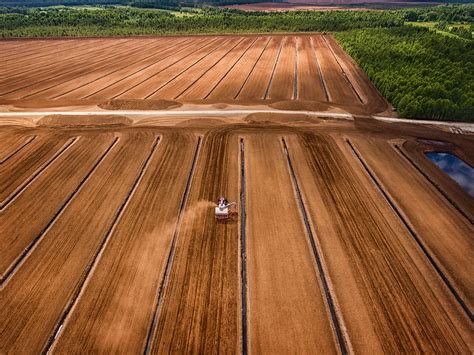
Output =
[{"x1": 425, "y1": 152, "x2": 474, "y2": 197}]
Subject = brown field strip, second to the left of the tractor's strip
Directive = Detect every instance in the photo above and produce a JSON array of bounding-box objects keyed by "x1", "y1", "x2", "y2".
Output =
[{"x1": 0, "y1": 132, "x2": 157, "y2": 352}]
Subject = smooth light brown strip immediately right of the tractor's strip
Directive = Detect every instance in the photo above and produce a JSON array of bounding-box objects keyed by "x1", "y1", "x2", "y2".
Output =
[{"x1": 244, "y1": 134, "x2": 337, "y2": 353}]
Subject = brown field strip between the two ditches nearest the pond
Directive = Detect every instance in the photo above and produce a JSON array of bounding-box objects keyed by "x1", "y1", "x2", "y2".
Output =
[{"x1": 353, "y1": 139, "x2": 474, "y2": 314}]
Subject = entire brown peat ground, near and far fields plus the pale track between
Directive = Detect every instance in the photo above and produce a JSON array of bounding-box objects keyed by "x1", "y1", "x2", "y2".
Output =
[{"x1": 0, "y1": 34, "x2": 474, "y2": 354}]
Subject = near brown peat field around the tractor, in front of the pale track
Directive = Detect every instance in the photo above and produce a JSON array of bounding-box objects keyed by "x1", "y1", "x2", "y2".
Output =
[{"x1": 0, "y1": 114, "x2": 474, "y2": 353}]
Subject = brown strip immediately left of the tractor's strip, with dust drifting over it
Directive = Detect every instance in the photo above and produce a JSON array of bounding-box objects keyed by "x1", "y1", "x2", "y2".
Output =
[{"x1": 54, "y1": 133, "x2": 197, "y2": 353}]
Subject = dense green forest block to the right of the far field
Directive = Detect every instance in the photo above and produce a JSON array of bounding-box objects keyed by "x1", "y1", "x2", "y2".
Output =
[{"x1": 335, "y1": 26, "x2": 474, "y2": 122}]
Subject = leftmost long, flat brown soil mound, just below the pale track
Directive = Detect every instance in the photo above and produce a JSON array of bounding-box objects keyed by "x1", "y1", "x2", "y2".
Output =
[{"x1": 38, "y1": 115, "x2": 133, "y2": 127}]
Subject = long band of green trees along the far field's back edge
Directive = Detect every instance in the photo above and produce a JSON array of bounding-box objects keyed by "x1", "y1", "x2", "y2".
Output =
[{"x1": 0, "y1": 7, "x2": 403, "y2": 37}]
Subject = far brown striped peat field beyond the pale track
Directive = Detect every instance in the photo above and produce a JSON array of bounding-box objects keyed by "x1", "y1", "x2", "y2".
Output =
[{"x1": 0, "y1": 34, "x2": 389, "y2": 114}]
